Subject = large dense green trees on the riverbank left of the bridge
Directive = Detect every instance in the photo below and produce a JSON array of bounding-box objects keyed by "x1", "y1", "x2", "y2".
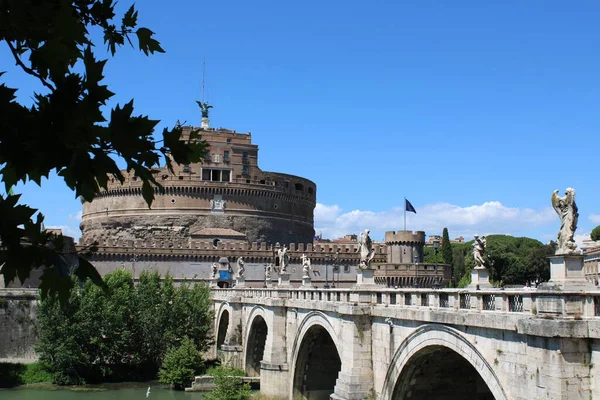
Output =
[{"x1": 37, "y1": 270, "x2": 212, "y2": 384}]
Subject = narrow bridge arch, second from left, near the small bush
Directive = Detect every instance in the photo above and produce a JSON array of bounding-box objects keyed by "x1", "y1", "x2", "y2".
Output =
[{"x1": 243, "y1": 306, "x2": 269, "y2": 376}]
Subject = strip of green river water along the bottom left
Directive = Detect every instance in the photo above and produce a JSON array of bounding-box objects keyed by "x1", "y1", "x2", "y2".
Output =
[{"x1": 0, "y1": 382, "x2": 207, "y2": 400}]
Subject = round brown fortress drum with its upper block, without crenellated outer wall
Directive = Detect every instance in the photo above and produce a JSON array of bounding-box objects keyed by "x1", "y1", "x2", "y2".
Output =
[{"x1": 81, "y1": 127, "x2": 317, "y2": 243}]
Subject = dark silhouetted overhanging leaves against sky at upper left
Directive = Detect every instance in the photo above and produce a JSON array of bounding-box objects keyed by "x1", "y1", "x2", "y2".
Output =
[{"x1": 0, "y1": 0, "x2": 206, "y2": 301}]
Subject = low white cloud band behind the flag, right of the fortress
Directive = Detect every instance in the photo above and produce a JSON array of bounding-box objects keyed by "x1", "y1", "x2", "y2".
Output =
[{"x1": 315, "y1": 201, "x2": 556, "y2": 239}]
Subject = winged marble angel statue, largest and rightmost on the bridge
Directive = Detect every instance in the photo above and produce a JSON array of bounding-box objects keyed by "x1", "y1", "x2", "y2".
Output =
[{"x1": 552, "y1": 188, "x2": 579, "y2": 254}]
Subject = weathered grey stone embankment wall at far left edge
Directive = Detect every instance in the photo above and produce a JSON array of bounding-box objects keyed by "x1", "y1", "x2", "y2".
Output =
[{"x1": 0, "y1": 289, "x2": 38, "y2": 363}]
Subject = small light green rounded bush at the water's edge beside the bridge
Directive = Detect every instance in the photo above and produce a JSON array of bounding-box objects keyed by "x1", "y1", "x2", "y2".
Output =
[{"x1": 158, "y1": 337, "x2": 203, "y2": 389}]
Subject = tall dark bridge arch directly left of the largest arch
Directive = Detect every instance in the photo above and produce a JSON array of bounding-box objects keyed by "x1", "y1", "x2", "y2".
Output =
[{"x1": 289, "y1": 311, "x2": 342, "y2": 399}]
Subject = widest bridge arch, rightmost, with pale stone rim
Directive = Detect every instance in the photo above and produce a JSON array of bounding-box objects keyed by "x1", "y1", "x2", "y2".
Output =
[{"x1": 381, "y1": 324, "x2": 508, "y2": 400}]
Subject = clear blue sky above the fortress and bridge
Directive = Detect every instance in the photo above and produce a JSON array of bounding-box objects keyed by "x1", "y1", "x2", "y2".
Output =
[{"x1": 0, "y1": 0, "x2": 600, "y2": 242}]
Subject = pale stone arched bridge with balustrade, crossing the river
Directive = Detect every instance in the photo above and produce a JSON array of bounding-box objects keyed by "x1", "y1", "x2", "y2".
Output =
[{"x1": 212, "y1": 288, "x2": 600, "y2": 400}]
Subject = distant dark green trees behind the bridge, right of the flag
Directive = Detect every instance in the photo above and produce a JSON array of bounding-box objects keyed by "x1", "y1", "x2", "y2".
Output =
[{"x1": 453, "y1": 235, "x2": 556, "y2": 286}]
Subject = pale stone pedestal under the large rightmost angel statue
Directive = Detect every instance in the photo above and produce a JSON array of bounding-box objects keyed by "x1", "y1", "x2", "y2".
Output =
[{"x1": 539, "y1": 254, "x2": 596, "y2": 290}]
